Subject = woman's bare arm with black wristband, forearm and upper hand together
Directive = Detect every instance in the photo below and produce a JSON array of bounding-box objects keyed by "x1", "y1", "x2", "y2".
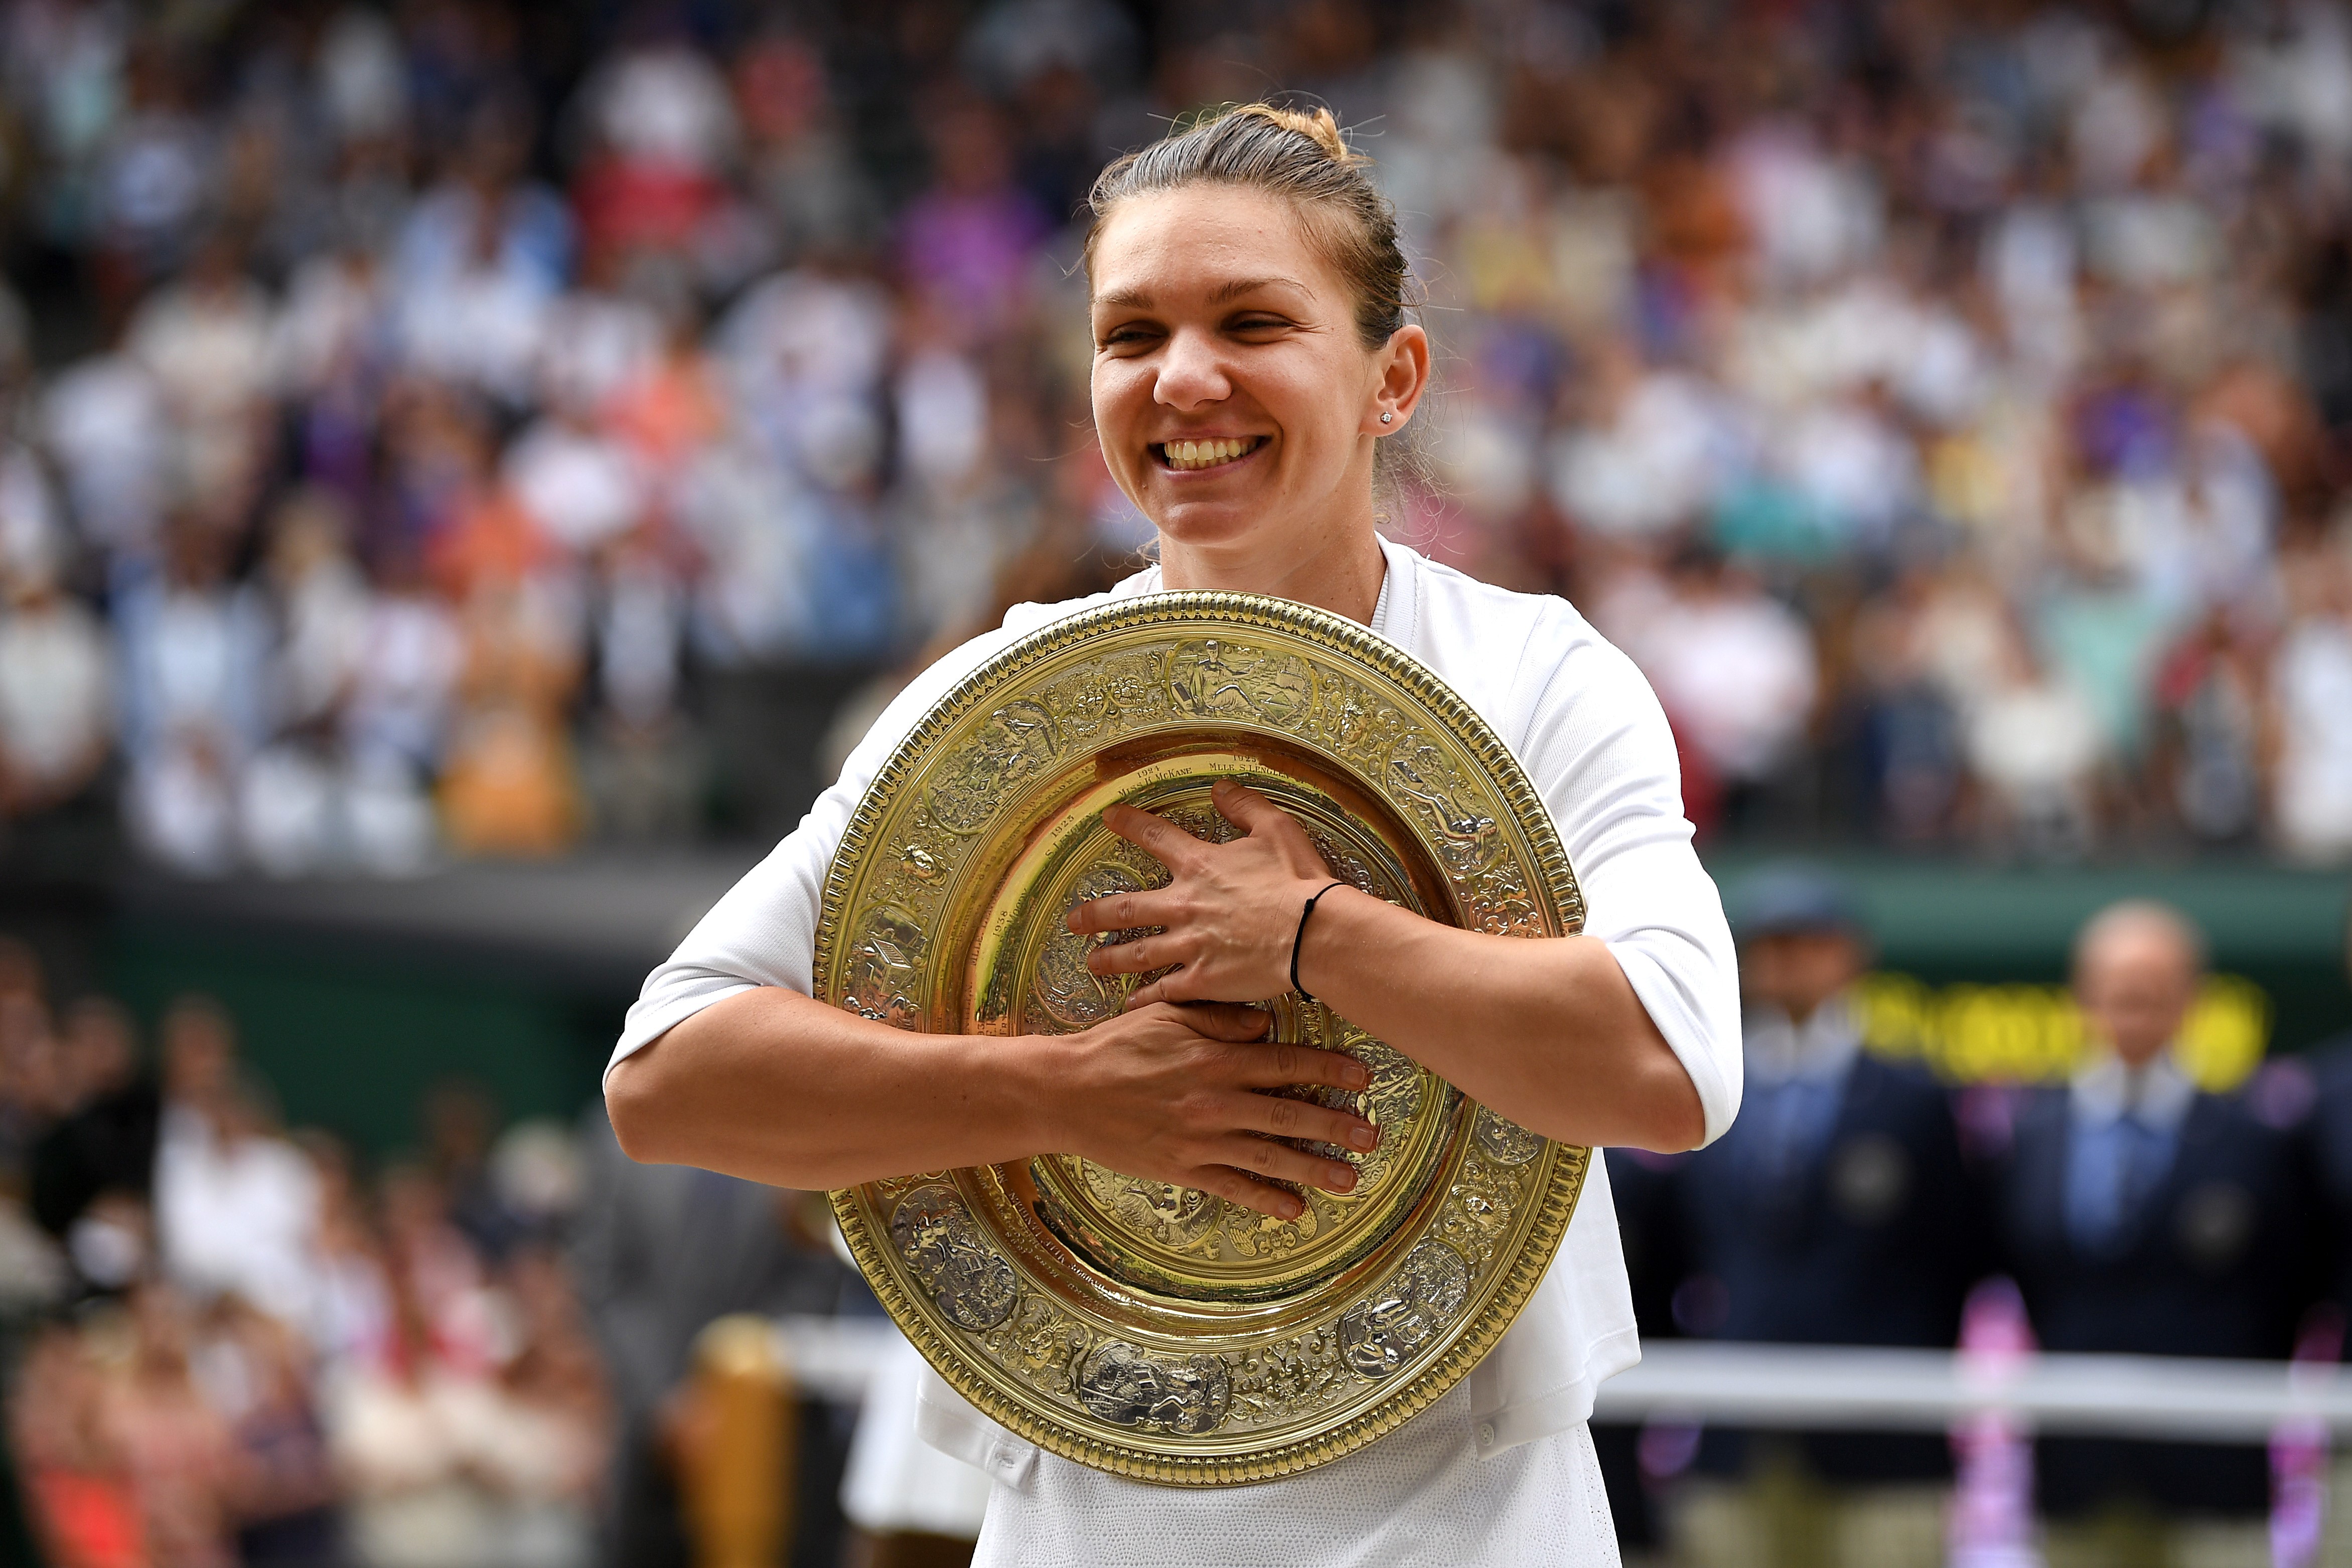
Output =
[{"x1": 1070, "y1": 780, "x2": 1705, "y2": 1150}]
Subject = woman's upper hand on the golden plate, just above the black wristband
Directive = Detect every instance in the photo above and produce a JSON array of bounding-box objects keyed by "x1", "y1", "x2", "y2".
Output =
[{"x1": 1070, "y1": 778, "x2": 1336, "y2": 1009}]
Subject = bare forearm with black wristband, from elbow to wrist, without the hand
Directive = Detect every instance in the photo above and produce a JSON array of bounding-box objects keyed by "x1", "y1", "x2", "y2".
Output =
[{"x1": 1298, "y1": 889, "x2": 1705, "y2": 1152}]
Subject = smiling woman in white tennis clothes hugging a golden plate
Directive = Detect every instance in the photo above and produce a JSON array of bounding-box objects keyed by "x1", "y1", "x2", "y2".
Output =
[{"x1": 607, "y1": 103, "x2": 1740, "y2": 1563}]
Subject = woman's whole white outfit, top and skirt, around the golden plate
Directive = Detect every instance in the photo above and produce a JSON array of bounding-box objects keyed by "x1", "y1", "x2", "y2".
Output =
[{"x1": 614, "y1": 543, "x2": 1740, "y2": 1563}]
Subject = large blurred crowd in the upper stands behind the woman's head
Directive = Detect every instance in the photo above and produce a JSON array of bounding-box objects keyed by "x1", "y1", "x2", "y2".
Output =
[{"x1": 0, "y1": 0, "x2": 2352, "y2": 872}]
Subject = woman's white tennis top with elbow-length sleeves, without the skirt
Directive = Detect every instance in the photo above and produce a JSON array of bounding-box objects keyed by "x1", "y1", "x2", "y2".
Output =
[{"x1": 612, "y1": 541, "x2": 1740, "y2": 1561}]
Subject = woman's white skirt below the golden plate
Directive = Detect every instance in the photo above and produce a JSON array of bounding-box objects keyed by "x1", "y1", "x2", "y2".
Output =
[{"x1": 971, "y1": 1384, "x2": 1618, "y2": 1568}]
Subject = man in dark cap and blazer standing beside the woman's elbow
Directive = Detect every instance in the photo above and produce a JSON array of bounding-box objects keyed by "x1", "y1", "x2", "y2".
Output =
[{"x1": 1674, "y1": 867, "x2": 1990, "y2": 1568}]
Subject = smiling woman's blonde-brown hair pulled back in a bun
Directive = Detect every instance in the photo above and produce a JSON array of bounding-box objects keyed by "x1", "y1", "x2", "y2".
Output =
[{"x1": 1087, "y1": 103, "x2": 1406, "y2": 348}]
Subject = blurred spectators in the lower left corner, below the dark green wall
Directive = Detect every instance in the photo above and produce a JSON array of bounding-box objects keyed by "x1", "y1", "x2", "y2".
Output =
[{"x1": 0, "y1": 945, "x2": 614, "y2": 1568}]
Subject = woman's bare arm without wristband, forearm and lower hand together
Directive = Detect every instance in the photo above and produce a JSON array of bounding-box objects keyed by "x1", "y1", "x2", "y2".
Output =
[{"x1": 605, "y1": 985, "x2": 1378, "y2": 1218}]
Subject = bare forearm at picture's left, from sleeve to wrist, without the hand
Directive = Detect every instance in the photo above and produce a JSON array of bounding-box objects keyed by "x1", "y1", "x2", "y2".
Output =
[{"x1": 605, "y1": 985, "x2": 1044, "y2": 1189}]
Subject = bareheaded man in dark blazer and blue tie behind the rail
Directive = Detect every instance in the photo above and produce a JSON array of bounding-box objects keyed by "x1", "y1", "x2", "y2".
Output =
[{"x1": 1999, "y1": 903, "x2": 2319, "y2": 1568}]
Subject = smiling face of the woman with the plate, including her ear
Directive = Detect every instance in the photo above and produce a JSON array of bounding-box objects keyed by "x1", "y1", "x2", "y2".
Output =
[{"x1": 1094, "y1": 186, "x2": 1428, "y2": 555}]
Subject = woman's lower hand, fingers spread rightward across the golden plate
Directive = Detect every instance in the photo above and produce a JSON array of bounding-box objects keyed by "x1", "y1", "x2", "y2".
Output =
[{"x1": 1028, "y1": 1002, "x2": 1381, "y2": 1220}]
